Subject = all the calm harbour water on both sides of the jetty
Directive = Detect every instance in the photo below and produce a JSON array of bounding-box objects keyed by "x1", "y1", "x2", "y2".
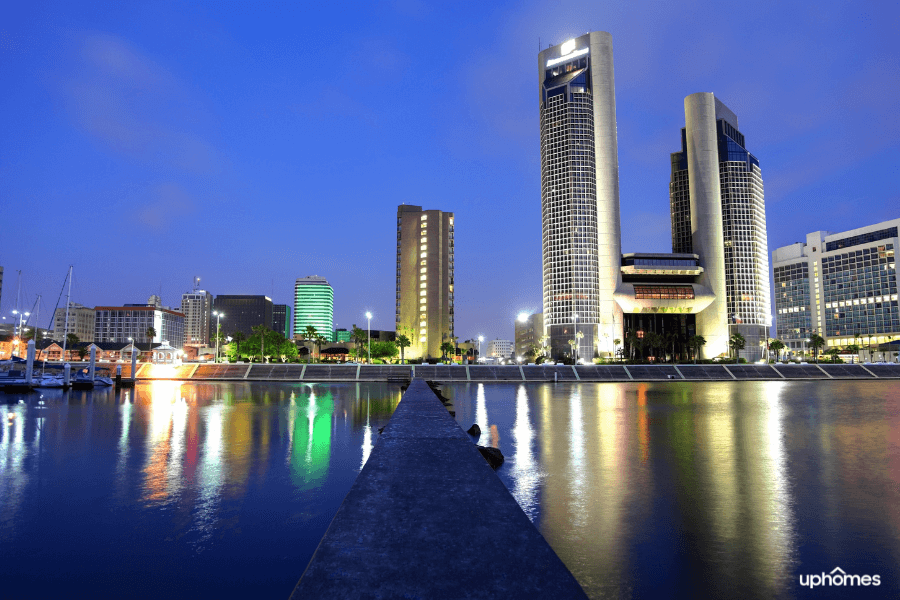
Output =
[{"x1": 0, "y1": 381, "x2": 900, "y2": 598}]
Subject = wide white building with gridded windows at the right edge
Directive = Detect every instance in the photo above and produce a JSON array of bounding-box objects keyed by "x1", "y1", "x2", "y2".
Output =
[{"x1": 772, "y1": 218, "x2": 900, "y2": 352}]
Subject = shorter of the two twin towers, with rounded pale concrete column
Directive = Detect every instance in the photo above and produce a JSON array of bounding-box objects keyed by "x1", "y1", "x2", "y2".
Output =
[{"x1": 669, "y1": 93, "x2": 772, "y2": 360}]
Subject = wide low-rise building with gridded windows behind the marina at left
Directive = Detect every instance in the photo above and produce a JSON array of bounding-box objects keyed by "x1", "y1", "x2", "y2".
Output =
[{"x1": 94, "y1": 304, "x2": 184, "y2": 344}]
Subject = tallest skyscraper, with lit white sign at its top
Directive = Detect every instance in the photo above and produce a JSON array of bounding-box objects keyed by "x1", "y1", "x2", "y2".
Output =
[{"x1": 538, "y1": 31, "x2": 622, "y2": 357}]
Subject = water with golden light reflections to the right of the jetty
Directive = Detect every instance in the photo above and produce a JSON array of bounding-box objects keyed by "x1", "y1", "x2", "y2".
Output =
[{"x1": 443, "y1": 381, "x2": 900, "y2": 598}]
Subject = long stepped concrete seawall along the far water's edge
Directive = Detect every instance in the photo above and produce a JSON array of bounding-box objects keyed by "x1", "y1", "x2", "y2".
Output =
[{"x1": 112, "y1": 363, "x2": 900, "y2": 383}]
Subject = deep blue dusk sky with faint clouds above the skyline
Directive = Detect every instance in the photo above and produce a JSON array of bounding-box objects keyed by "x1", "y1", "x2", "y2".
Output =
[{"x1": 0, "y1": 0, "x2": 900, "y2": 340}]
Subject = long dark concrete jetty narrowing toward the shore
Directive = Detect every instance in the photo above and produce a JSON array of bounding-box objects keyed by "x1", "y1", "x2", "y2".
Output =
[{"x1": 291, "y1": 378, "x2": 587, "y2": 600}]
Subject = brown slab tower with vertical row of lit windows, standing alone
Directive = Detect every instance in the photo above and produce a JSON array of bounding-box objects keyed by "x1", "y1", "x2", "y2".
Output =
[{"x1": 396, "y1": 204, "x2": 454, "y2": 358}]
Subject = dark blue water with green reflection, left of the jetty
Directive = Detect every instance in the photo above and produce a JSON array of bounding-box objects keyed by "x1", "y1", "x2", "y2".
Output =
[{"x1": 0, "y1": 381, "x2": 400, "y2": 599}]
